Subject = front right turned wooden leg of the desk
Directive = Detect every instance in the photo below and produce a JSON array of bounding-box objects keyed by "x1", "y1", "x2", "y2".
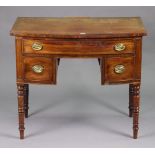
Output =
[{"x1": 131, "y1": 83, "x2": 140, "y2": 139}]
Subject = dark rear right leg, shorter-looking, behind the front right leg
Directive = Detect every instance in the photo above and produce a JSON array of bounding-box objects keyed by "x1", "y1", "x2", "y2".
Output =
[{"x1": 129, "y1": 84, "x2": 133, "y2": 117}]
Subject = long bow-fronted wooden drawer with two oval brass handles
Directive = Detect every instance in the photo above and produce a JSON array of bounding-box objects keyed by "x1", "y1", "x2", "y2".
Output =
[{"x1": 23, "y1": 39, "x2": 135, "y2": 55}]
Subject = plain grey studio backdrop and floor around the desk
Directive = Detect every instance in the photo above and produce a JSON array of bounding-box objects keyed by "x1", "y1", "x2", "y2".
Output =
[{"x1": 0, "y1": 7, "x2": 155, "y2": 147}]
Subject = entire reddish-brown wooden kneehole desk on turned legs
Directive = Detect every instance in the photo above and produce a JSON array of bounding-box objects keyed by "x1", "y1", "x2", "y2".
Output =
[{"x1": 10, "y1": 17, "x2": 146, "y2": 139}]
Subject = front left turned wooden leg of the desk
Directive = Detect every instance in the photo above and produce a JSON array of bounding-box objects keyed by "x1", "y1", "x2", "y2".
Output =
[{"x1": 17, "y1": 84, "x2": 25, "y2": 139}]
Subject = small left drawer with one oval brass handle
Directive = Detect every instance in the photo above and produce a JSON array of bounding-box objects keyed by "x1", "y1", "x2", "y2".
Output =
[{"x1": 24, "y1": 57, "x2": 56, "y2": 84}]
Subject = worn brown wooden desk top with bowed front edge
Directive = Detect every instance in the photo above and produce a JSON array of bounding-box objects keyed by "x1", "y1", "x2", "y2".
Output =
[{"x1": 10, "y1": 17, "x2": 146, "y2": 38}]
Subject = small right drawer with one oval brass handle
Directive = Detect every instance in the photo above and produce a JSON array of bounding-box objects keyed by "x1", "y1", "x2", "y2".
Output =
[{"x1": 102, "y1": 56, "x2": 134, "y2": 83}]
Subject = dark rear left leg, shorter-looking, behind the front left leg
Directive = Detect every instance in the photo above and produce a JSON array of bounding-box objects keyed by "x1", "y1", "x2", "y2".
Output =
[{"x1": 24, "y1": 84, "x2": 29, "y2": 118}]
